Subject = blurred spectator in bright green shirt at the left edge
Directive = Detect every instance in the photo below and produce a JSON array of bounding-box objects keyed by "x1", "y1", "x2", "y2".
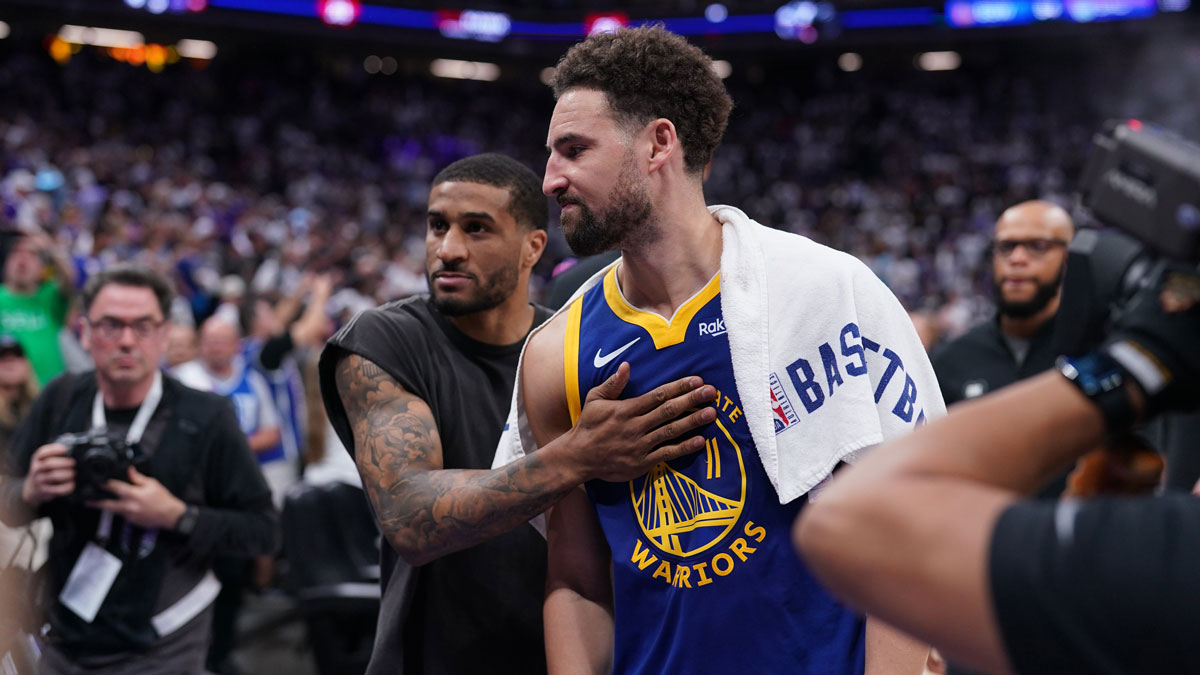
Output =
[{"x1": 0, "y1": 231, "x2": 74, "y2": 384}]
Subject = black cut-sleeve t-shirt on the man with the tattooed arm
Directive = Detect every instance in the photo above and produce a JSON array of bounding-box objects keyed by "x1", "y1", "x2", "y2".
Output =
[{"x1": 319, "y1": 295, "x2": 550, "y2": 675}]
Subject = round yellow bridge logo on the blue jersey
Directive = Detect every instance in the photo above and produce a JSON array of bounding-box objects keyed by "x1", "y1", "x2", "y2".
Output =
[{"x1": 629, "y1": 420, "x2": 746, "y2": 556}]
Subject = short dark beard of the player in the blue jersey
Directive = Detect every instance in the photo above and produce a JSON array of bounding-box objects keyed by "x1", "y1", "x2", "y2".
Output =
[{"x1": 558, "y1": 153, "x2": 654, "y2": 257}]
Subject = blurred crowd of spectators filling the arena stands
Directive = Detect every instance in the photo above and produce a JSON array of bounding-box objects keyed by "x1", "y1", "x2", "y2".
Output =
[{"x1": 0, "y1": 22, "x2": 1200, "y2": 669}]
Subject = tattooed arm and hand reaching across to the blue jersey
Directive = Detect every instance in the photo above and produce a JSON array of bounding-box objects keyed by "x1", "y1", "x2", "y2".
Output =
[{"x1": 336, "y1": 336, "x2": 713, "y2": 565}]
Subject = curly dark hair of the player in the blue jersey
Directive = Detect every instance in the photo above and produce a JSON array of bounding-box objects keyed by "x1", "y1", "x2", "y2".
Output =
[{"x1": 551, "y1": 25, "x2": 733, "y2": 173}]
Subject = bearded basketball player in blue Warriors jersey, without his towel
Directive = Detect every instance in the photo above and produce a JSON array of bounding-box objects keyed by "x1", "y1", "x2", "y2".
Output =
[{"x1": 520, "y1": 28, "x2": 928, "y2": 674}]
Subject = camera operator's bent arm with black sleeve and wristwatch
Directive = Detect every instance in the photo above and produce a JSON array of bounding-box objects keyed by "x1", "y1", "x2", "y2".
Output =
[{"x1": 794, "y1": 264, "x2": 1200, "y2": 673}]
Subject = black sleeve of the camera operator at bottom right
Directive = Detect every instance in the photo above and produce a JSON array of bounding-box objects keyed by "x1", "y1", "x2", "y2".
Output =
[{"x1": 989, "y1": 495, "x2": 1200, "y2": 675}]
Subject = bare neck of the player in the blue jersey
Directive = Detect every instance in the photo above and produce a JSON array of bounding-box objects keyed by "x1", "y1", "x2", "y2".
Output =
[{"x1": 617, "y1": 201, "x2": 721, "y2": 316}]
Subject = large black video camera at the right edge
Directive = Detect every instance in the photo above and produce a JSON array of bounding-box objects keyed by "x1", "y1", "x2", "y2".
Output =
[{"x1": 1055, "y1": 120, "x2": 1200, "y2": 357}]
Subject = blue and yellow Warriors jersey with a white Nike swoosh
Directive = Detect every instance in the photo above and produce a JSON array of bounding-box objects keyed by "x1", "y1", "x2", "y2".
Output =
[{"x1": 565, "y1": 269, "x2": 864, "y2": 675}]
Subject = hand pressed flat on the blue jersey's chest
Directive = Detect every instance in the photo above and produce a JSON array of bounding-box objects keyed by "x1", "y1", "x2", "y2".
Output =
[{"x1": 566, "y1": 363, "x2": 716, "y2": 483}]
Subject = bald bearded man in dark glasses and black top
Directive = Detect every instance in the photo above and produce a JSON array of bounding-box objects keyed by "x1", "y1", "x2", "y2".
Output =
[{"x1": 932, "y1": 201, "x2": 1075, "y2": 494}]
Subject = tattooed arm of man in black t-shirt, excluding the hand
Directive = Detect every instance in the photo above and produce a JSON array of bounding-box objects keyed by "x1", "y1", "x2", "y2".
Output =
[{"x1": 336, "y1": 354, "x2": 574, "y2": 562}]
